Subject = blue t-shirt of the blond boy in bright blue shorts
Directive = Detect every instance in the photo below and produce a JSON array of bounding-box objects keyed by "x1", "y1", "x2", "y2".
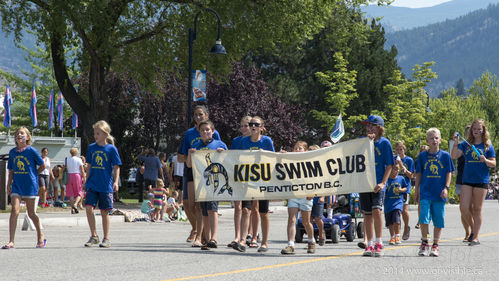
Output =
[{"x1": 416, "y1": 150, "x2": 454, "y2": 202}]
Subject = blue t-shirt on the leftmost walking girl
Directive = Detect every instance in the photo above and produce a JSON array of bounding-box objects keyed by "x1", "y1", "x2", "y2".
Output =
[{"x1": 7, "y1": 146, "x2": 44, "y2": 196}]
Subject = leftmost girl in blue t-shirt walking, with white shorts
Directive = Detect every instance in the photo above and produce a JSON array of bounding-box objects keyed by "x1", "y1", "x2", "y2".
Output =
[{"x1": 2, "y1": 127, "x2": 47, "y2": 249}]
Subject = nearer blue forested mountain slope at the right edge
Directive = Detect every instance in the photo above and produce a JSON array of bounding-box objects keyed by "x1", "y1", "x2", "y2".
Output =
[{"x1": 385, "y1": 4, "x2": 499, "y2": 96}]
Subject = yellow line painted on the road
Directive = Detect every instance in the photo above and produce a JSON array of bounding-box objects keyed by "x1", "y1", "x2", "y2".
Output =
[{"x1": 163, "y1": 232, "x2": 499, "y2": 281}]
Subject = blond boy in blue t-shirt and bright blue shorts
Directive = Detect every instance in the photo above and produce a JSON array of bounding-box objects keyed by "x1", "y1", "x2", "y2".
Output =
[{"x1": 415, "y1": 128, "x2": 454, "y2": 257}]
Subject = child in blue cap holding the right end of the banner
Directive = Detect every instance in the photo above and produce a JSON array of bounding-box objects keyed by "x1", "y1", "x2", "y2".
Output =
[{"x1": 359, "y1": 115, "x2": 394, "y2": 257}]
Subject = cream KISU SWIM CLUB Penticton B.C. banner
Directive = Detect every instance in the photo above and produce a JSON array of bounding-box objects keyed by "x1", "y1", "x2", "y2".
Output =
[{"x1": 192, "y1": 138, "x2": 376, "y2": 201}]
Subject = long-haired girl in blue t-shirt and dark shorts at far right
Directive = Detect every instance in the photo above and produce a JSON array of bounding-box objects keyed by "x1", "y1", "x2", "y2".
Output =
[{"x1": 451, "y1": 119, "x2": 496, "y2": 246}]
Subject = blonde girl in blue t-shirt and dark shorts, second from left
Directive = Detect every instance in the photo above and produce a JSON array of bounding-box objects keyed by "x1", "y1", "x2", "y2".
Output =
[{"x1": 85, "y1": 120, "x2": 121, "y2": 248}]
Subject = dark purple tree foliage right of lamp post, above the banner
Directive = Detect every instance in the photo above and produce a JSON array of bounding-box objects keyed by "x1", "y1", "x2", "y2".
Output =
[{"x1": 207, "y1": 63, "x2": 305, "y2": 150}]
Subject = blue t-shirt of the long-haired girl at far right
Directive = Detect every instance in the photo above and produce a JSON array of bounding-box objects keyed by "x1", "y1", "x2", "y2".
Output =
[{"x1": 457, "y1": 142, "x2": 496, "y2": 183}]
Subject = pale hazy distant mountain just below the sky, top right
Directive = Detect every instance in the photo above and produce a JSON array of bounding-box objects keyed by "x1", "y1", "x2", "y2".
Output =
[{"x1": 362, "y1": 0, "x2": 499, "y2": 33}]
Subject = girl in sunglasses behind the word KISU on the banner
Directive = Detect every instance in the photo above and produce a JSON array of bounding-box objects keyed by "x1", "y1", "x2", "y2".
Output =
[{"x1": 233, "y1": 116, "x2": 275, "y2": 252}]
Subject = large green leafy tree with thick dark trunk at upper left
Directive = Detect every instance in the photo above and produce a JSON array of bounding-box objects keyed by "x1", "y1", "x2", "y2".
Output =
[{"x1": 0, "y1": 0, "x2": 386, "y2": 143}]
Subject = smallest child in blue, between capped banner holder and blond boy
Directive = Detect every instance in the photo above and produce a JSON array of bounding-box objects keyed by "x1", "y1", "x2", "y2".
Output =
[{"x1": 384, "y1": 163, "x2": 408, "y2": 245}]
